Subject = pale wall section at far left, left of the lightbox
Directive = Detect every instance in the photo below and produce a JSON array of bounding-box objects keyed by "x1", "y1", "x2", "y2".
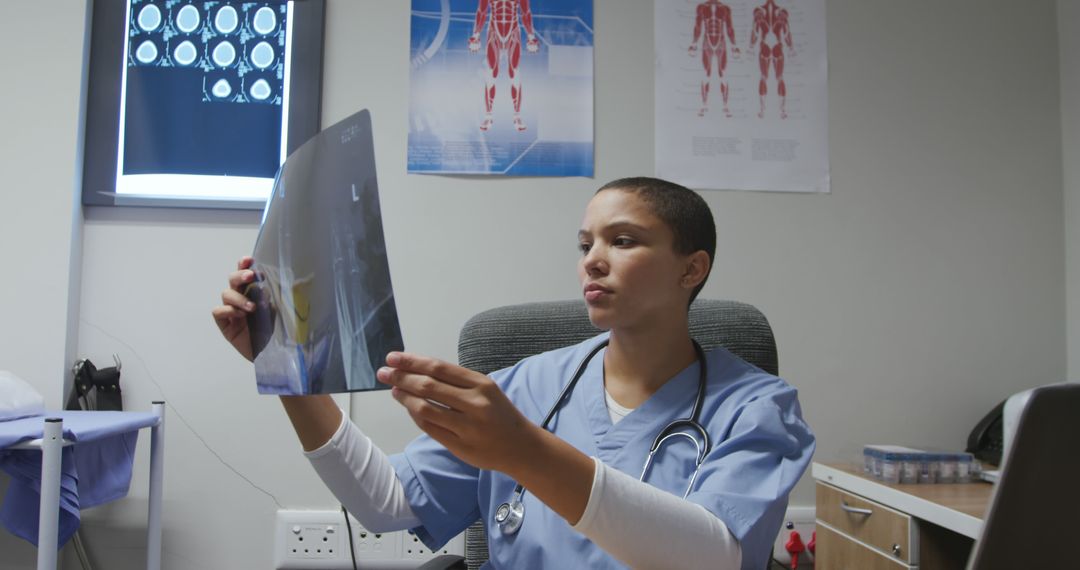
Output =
[{"x1": 0, "y1": 0, "x2": 87, "y2": 568}]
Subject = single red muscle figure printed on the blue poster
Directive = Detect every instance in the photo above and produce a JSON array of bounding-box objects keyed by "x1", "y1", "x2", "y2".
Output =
[{"x1": 469, "y1": 0, "x2": 540, "y2": 131}]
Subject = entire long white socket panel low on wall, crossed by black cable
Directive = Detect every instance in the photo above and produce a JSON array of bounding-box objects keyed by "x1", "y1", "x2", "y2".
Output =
[{"x1": 274, "y1": 510, "x2": 465, "y2": 570}]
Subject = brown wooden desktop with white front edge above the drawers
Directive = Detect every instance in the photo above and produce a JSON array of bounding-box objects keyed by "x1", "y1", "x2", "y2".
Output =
[{"x1": 811, "y1": 463, "x2": 994, "y2": 539}]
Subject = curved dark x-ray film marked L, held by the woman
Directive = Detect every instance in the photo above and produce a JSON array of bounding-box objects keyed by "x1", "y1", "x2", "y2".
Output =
[{"x1": 247, "y1": 110, "x2": 404, "y2": 395}]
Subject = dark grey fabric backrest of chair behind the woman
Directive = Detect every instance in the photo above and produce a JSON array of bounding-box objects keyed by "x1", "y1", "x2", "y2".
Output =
[{"x1": 458, "y1": 299, "x2": 779, "y2": 569}]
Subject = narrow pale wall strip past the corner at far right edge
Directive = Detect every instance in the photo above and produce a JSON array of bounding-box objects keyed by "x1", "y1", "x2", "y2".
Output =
[{"x1": 1057, "y1": 0, "x2": 1080, "y2": 381}]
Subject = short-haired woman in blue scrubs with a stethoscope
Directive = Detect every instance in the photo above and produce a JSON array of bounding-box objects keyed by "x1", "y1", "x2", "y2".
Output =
[{"x1": 213, "y1": 178, "x2": 814, "y2": 569}]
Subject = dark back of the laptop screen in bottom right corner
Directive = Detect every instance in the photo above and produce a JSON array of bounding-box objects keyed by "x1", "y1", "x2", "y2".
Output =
[{"x1": 968, "y1": 383, "x2": 1080, "y2": 570}]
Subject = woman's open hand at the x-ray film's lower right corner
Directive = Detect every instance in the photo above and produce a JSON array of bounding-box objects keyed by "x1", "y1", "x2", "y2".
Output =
[{"x1": 377, "y1": 352, "x2": 538, "y2": 473}]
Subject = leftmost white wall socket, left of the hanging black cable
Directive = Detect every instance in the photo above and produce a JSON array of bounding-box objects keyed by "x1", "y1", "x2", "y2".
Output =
[{"x1": 274, "y1": 511, "x2": 352, "y2": 570}]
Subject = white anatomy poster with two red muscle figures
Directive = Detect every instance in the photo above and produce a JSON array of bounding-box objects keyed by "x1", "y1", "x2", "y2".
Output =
[{"x1": 656, "y1": 0, "x2": 829, "y2": 192}]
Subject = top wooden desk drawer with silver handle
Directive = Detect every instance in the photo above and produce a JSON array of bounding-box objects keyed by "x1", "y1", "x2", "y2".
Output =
[{"x1": 818, "y1": 483, "x2": 918, "y2": 564}]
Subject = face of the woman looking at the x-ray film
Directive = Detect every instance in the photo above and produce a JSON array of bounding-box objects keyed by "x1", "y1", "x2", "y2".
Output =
[{"x1": 578, "y1": 188, "x2": 690, "y2": 330}]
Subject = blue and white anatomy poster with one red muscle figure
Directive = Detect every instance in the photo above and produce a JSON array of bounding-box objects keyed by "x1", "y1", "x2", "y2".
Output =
[{"x1": 408, "y1": 0, "x2": 593, "y2": 176}]
